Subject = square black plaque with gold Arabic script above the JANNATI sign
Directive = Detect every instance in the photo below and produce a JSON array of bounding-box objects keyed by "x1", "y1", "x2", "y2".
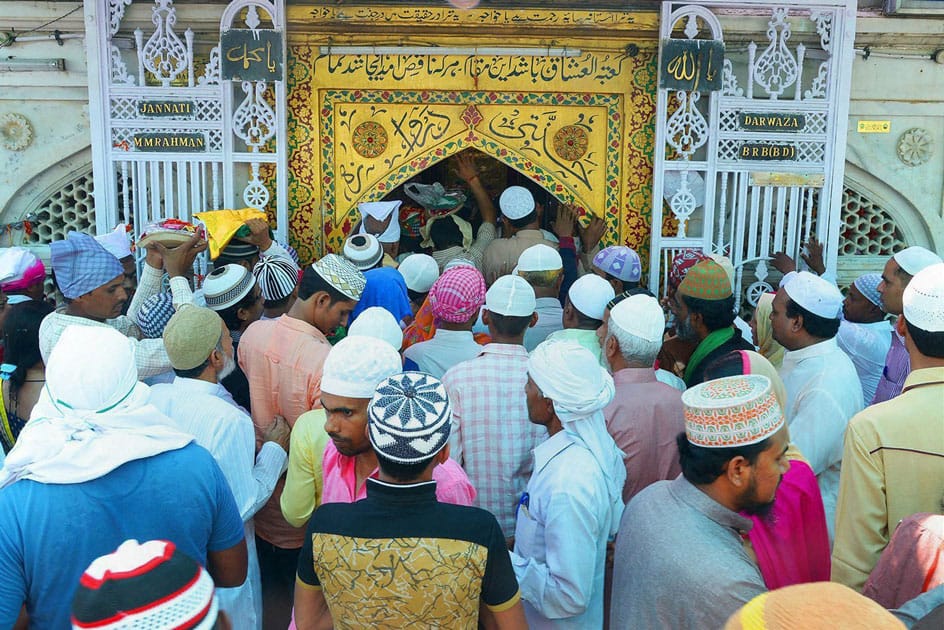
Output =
[{"x1": 220, "y1": 28, "x2": 283, "y2": 81}]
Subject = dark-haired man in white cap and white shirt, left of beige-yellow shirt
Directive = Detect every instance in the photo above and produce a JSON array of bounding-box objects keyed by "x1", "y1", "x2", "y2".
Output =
[{"x1": 770, "y1": 271, "x2": 864, "y2": 540}]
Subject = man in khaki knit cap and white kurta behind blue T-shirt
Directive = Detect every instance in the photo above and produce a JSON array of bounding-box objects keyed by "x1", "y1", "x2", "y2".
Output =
[{"x1": 150, "y1": 305, "x2": 290, "y2": 630}]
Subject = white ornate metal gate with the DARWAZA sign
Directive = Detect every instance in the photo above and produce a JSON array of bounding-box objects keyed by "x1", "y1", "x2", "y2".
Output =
[{"x1": 650, "y1": 0, "x2": 856, "y2": 304}]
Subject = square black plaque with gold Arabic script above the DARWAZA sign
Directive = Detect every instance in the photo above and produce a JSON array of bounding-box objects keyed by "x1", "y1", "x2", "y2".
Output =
[{"x1": 659, "y1": 39, "x2": 724, "y2": 92}]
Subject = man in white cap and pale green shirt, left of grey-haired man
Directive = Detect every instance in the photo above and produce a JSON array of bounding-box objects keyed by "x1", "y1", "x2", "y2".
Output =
[{"x1": 548, "y1": 273, "x2": 616, "y2": 367}]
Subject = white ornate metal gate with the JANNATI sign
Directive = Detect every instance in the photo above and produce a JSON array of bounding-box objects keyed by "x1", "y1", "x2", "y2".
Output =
[{"x1": 85, "y1": 0, "x2": 288, "y2": 264}]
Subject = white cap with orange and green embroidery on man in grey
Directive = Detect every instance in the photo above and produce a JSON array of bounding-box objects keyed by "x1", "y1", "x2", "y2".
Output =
[{"x1": 682, "y1": 374, "x2": 784, "y2": 448}]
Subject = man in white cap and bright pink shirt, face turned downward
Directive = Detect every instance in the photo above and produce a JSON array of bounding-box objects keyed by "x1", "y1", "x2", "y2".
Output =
[{"x1": 321, "y1": 337, "x2": 475, "y2": 505}]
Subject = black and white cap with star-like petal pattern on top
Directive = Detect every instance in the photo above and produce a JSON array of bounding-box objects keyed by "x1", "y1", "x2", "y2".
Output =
[{"x1": 367, "y1": 372, "x2": 452, "y2": 464}]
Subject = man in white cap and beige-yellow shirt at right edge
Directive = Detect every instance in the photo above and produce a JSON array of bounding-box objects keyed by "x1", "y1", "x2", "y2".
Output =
[{"x1": 832, "y1": 263, "x2": 944, "y2": 590}]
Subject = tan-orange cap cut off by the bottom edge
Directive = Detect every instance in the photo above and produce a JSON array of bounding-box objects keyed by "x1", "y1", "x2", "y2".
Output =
[{"x1": 724, "y1": 582, "x2": 905, "y2": 630}]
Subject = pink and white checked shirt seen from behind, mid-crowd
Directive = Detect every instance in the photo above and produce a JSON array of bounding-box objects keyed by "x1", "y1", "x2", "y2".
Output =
[{"x1": 442, "y1": 343, "x2": 547, "y2": 537}]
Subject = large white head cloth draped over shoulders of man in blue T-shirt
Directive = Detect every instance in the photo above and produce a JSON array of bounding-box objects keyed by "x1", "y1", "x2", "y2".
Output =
[{"x1": 0, "y1": 325, "x2": 193, "y2": 488}]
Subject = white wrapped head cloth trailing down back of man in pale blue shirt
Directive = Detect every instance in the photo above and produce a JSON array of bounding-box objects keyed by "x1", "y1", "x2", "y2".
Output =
[{"x1": 528, "y1": 340, "x2": 626, "y2": 538}]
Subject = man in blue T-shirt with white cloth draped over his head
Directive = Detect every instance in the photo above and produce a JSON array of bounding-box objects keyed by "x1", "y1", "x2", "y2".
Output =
[{"x1": 0, "y1": 326, "x2": 247, "y2": 628}]
